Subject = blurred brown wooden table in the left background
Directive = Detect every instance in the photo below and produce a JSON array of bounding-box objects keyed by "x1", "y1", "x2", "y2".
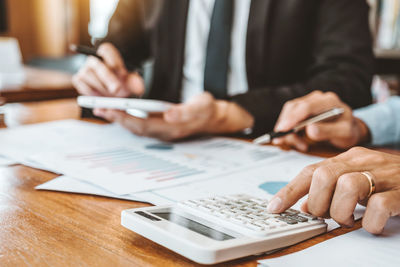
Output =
[{"x1": 0, "y1": 67, "x2": 77, "y2": 103}]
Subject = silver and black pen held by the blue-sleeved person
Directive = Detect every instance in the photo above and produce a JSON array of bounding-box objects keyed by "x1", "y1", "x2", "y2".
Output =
[{"x1": 253, "y1": 108, "x2": 344, "y2": 145}]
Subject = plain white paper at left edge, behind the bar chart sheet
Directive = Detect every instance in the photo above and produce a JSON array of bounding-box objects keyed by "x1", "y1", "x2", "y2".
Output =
[{"x1": 0, "y1": 120, "x2": 155, "y2": 171}]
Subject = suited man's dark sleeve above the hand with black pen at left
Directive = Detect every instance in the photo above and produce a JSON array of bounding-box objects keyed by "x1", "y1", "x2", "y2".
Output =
[{"x1": 97, "y1": 0, "x2": 153, "y2": 69}]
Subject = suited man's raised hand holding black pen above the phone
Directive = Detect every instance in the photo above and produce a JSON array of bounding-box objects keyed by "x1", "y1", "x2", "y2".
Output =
[{"x1": 73, "y1": 43, "x2": 144, "y2": 97}]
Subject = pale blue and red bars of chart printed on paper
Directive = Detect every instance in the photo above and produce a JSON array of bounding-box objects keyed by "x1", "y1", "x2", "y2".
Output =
[{"x1": 68, "y1": 148, "x2": 204, "y2": 182}]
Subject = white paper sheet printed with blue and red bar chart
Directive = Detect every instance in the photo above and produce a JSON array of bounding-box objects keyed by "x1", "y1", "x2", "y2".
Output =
[{"x1": 34, "y1": 147, "x2": 218, "y2": 195}]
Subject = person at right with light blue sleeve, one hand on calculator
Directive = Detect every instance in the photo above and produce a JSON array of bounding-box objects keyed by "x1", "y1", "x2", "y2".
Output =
[{"x1": 268, "y1": 91, "x2": 400, "y2": 234}]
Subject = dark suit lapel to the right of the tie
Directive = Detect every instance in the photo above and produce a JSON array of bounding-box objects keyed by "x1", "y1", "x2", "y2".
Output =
[{"x1": 246, "y1": 0, "x2": 273, "y2": 88}]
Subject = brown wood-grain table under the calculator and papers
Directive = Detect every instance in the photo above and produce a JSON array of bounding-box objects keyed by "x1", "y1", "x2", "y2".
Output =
[{"x1": 0, "y1": 100, "x2": 394, "y2": 266}]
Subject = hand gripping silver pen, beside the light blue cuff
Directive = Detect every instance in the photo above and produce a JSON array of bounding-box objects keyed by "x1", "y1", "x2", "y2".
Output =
[{"x1": 273, "y1": 91, "x2": 369, "y2": 151}]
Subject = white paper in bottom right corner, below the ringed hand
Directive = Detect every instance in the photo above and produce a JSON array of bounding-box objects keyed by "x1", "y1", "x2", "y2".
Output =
[{"x1": 259, "y1": 217, "x2": 400, "y2": 267}]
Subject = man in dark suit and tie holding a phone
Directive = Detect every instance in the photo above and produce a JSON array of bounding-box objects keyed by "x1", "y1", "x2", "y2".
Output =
[{"x1": 74, "y1": 0, "x2": 373, "y2": 140}]
